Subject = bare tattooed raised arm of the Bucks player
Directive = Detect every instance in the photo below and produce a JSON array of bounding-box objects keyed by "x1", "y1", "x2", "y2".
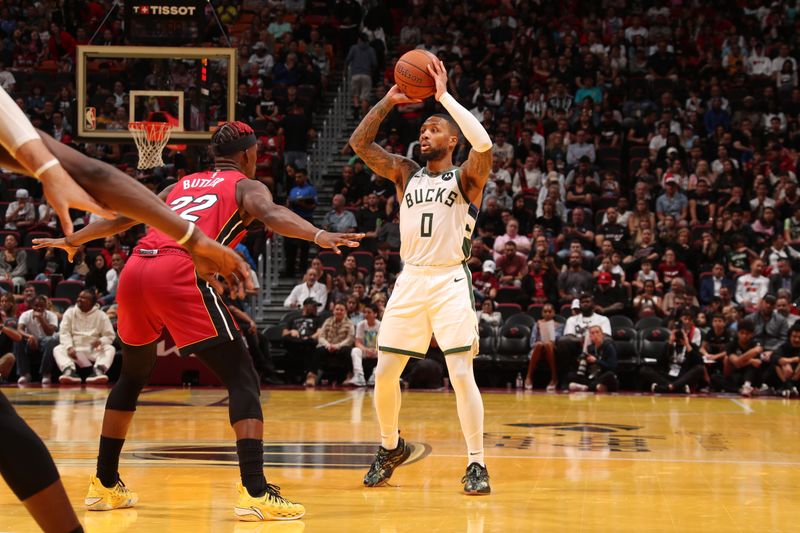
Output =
[{"x1": 350, "y1": 85, "x2": 420, "y2": 189}]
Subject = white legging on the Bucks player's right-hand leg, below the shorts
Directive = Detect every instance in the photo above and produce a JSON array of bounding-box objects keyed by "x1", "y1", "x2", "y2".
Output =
[{"x1": 445, "y1": 353, "x2": 486, "y2": 466}]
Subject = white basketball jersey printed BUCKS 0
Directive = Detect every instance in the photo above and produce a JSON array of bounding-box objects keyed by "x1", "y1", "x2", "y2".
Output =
[{"x1": 400, "y1": 167, "x2": 478, "y2": 266}]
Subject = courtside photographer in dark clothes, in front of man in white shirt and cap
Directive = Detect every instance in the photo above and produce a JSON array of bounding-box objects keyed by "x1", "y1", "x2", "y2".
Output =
[{"x1": 567, "y1": 325, "x2": 619, "y2": 392}]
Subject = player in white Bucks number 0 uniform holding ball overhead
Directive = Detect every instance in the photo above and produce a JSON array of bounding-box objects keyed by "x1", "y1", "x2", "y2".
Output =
[{"x1": 350, "y1": 62, "x2": 492, "y2": 494}]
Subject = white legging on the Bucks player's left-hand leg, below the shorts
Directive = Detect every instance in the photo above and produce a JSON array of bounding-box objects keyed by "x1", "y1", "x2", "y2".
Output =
[{"x1": 373, "y1": 352, "x2": 408, "y2": 450}]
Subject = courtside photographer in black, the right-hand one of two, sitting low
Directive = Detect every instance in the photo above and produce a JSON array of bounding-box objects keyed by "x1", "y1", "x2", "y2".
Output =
[{"x1": 639, "y1": 324, "x2": 705, "y2": 394}]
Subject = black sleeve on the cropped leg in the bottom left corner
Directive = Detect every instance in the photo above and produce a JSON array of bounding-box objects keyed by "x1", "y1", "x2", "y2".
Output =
[{"x1": 0, "y1": 394, "x2": 59, "y2": 501}]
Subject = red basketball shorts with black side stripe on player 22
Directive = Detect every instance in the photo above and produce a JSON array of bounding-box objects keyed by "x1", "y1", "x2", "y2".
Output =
[{"x1": 117, "y1": 248, "x2": 239, "y2": 354}]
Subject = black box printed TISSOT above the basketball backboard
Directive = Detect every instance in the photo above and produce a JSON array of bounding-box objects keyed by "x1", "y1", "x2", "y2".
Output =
[{"x1": 125, "y1": 0, "x2": 205, "y2": 46}]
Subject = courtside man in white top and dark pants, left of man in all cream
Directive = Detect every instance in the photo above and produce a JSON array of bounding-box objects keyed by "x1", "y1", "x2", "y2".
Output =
[{"x1": 14, "y1": 296, "x2": 58, "y2": 385}]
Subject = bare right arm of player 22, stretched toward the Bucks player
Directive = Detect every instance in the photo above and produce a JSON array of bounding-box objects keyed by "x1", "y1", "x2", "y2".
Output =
[{"x1": 236, "y1": 180, "x2": 364, "y2": 254}]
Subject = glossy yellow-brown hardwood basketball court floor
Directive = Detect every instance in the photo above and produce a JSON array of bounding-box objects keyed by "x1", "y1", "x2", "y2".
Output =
[{"x1": 0, "y1": 388, "x2": 800, "y2": 533}]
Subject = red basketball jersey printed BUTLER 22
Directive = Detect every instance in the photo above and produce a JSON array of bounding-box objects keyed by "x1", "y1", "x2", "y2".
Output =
[{"x1": 138, "y1": 170, "x2": 248, "y2": 249}]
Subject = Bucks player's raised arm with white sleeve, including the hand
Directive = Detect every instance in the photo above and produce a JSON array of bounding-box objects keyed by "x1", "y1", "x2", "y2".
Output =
[{"x1": 428, "y1": 61, "x2": 492, "y2": 205}]
